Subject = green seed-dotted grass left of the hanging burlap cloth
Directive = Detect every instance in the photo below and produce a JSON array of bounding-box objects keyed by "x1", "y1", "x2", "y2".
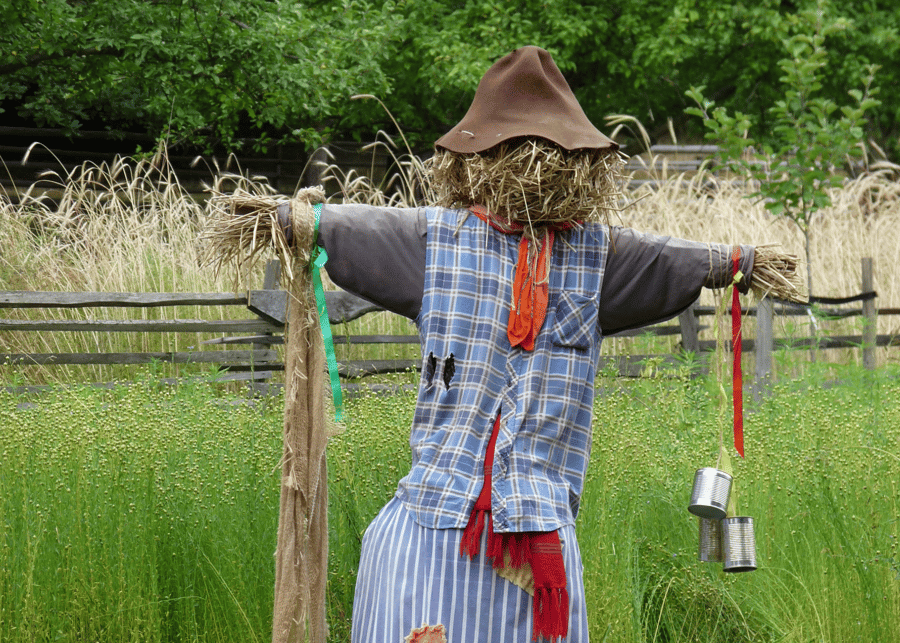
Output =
[{"x1": 0, "y1": 379, "x2": 280, "y2": 642}]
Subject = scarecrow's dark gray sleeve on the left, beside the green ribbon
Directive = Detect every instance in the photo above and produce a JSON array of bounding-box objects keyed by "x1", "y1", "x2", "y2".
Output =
[{"x1": 317, "y1": 204, "x2": 426, "y2": 319}]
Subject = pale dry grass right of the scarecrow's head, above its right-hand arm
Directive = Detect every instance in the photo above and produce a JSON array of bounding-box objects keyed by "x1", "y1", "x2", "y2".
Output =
[{"x1": 622, "y1": 171, "x2": 900, "y2": 308}]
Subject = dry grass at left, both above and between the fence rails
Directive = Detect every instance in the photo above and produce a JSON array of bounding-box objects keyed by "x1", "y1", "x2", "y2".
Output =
[{"x1": 0, "y1": 150, "x2": 247, "y2": 383}]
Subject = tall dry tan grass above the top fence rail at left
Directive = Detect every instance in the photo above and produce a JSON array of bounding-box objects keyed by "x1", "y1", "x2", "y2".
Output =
[{"x1": 0, "y1": 145, "x2": 215, "y2": 292}]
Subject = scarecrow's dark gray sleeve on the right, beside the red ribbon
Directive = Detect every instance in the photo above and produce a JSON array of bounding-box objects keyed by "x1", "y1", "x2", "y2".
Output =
[{"x1": 599, "y1": 227, "x2": 754, "y2": 335}]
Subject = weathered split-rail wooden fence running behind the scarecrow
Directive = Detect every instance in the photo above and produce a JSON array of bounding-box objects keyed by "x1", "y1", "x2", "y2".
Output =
[{"x1": 0, "y1": 259, "x2": 888, "y2": 394}]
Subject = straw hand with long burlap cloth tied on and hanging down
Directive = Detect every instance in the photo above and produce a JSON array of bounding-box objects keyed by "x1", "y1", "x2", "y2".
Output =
[{"x1": 202, "y1": 188, "x2": 328, "y2": 643}]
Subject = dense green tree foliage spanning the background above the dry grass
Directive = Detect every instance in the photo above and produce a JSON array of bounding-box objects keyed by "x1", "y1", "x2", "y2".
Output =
[{"x1": 0, "y1": 0, "x2": 900, "y2": 156}]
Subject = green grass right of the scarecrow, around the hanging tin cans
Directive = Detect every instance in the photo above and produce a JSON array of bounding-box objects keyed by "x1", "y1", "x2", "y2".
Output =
[{"x1": 579, "y1": 365, "x2": 900, "y2": 641}]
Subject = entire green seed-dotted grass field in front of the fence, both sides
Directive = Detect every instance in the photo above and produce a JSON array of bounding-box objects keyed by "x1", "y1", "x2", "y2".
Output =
[{"x1": 0, "y1": 365, "x2": 900, "y2": 643}]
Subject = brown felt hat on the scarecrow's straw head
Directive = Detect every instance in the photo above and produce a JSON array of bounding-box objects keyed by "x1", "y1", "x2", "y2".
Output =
[{"x1": 434, "y1": 47, "x2": 619, "y2": 154}]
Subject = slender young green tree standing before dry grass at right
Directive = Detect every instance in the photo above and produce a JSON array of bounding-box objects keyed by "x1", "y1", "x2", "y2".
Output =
[{"x1": 687, "y1": 0, "x2": 879, "y2": 290}]
